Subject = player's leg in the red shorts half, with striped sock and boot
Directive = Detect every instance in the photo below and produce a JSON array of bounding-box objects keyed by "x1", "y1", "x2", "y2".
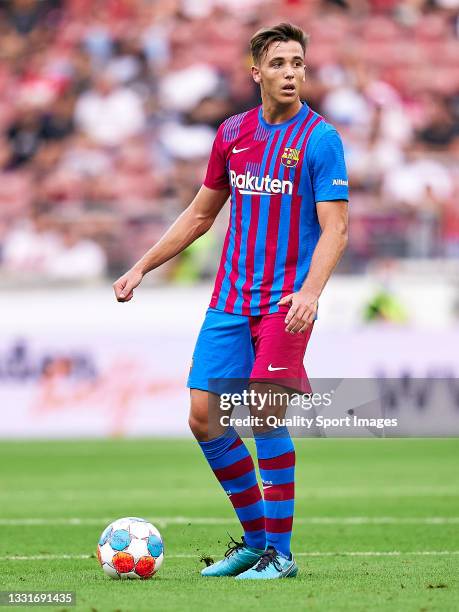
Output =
[{"x1": 238, "y1": 313, "x2": 312, "y2": 579}]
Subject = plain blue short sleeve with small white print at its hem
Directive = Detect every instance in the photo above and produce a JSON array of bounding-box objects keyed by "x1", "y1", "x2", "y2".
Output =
[{"x1": 310, "y1": 129, "x2": 349, "y2": 202}]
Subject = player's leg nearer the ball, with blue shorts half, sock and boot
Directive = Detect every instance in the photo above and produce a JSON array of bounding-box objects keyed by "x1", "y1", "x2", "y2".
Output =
[{"x1": 188, "y1": 309, "x2": 266, "y2": 576}]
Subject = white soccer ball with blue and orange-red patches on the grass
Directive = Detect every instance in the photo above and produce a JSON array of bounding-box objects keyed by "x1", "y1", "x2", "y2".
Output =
[{"x1": 97, "y1": 517, "x2": 164, "y2": 580}]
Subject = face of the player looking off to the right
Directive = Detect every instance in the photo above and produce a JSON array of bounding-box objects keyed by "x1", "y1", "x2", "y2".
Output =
[{"x1": 252, "y1": 40, "x2": 305, "y2": 104}]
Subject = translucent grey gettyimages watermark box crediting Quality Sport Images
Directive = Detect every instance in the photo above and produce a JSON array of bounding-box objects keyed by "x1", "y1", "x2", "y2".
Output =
[{"x1": 209, "y1": 376, "x2": 459, "y2": 438}]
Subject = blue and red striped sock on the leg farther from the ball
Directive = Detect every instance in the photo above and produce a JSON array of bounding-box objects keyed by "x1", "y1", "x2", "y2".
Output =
[{"x1": 255, "y1": 427, "x2": 295, "y2": 558}]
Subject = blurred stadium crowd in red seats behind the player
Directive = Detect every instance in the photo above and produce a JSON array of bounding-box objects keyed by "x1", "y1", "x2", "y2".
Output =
[{"x1": 0, "y1": 0, "x2": 459, "y2": 281}]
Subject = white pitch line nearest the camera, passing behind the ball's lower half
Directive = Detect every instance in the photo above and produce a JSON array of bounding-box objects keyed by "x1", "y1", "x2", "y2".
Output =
[{"x1": 0, "y1": 550, "x2": 459, "y2": 561}]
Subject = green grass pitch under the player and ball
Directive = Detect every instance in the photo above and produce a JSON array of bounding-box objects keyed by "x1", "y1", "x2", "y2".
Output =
[{"x1": 0, "y1": 439, "x2": 459, "y2": 612}]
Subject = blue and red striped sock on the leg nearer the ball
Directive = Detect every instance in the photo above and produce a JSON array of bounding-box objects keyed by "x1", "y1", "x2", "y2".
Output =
[{"x1": 199, "y1": 428, "x2": 266, "y2": 550}]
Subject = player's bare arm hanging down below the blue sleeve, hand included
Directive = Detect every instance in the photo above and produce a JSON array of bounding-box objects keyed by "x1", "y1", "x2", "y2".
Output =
[{"x1": 279, "y1": 200, "x2": 348, "y2": 334}]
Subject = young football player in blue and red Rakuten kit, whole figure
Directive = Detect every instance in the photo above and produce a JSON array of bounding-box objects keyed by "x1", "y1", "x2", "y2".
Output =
[{"x1": 114, "y1": 23, "x2": 348, "y2": 579}]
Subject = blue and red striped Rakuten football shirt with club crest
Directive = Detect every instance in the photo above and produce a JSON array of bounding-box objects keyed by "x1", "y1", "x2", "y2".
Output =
[{"x1": 204, "y1": 104, "x2": 349, "y2": 316}]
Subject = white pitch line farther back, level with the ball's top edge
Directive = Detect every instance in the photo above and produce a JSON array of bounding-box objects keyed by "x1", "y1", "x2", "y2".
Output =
[{"x1": 0, "y1": 516, "x2": 459, "y2": 527}]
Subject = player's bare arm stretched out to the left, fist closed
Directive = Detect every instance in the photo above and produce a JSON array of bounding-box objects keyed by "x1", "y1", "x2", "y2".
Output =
[{"x1": 113, "y1": 185, "x2": 229, "y2": 302}]
